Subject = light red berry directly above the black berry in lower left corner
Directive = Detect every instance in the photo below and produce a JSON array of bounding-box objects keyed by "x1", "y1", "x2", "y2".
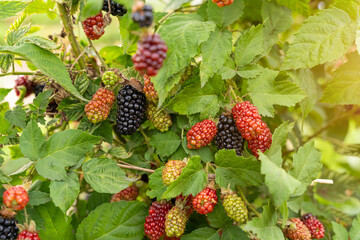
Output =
[{"x1": 0, "y1": 186, "x2": 29, "y2": 211}]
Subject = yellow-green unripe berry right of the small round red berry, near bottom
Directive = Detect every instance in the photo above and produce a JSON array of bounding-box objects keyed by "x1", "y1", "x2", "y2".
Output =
[{"x1": 222, "y1": 192, "x2": 248, "y2": 223}]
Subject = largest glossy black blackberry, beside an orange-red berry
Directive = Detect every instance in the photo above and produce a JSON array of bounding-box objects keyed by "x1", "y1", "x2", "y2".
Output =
[{"x1": 116, "y1": 85, "x2": 146, "y2": 135}]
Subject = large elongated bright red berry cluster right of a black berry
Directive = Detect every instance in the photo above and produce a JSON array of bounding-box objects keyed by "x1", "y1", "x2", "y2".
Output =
[{"x1": 232, "y1": 101, "x2": 272, "y2": 157}]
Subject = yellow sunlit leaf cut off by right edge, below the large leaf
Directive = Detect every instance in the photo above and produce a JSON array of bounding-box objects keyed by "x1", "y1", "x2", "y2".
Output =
[{"x1": 320, "y1": 56, "x2": 360, "y2": 104}]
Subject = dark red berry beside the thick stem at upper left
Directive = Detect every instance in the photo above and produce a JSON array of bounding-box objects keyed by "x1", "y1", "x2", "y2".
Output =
[{"x1": 82, "y1": 12, "x2": 105, "y2": 40}]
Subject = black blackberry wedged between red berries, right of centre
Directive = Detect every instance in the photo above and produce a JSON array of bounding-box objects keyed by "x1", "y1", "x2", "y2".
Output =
[{"x1": 215, "y1": 114, "x2": 244, "y2": 156}]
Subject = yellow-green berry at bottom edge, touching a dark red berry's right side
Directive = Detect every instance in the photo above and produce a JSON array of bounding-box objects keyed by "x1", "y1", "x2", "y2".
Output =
[{"x1": 165, "y1": 206, "x2": 188, "y2": 237}]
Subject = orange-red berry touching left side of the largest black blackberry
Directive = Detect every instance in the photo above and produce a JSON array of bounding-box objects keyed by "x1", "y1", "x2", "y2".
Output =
[{"x1": 85, "y1": 88, "x2": 115, "y2": 123}]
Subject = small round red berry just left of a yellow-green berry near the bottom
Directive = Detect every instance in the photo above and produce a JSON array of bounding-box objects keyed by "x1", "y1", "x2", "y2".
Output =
[{"x1": 193, "y1": 187, "x2": 217, "y2": 214}]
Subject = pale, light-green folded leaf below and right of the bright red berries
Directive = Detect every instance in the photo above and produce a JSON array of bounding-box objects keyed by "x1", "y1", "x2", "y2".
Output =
[{"x1": 259, "y1": 151, "x2": 301, "y2": 207}]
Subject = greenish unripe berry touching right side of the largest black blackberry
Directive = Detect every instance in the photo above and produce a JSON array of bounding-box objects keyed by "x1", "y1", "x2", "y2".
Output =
[{"x1": 146, "y1": 102, "x2": 172, "y2": 132}]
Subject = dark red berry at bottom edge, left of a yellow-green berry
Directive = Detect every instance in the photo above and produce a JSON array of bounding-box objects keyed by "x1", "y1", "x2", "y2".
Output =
[{"x1": 144, "y1": 200, "x2": 171, "y2": 240}]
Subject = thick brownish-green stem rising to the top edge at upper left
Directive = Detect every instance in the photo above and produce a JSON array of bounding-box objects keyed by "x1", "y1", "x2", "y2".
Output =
[{"x1": 57, "y1": 3, "x2": 86, "y2": 69}]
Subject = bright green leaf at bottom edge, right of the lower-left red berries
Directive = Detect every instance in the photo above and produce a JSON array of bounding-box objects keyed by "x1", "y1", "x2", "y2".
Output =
[{"x1": 36, "y1": 202, "x2": 74, "y2": 240}]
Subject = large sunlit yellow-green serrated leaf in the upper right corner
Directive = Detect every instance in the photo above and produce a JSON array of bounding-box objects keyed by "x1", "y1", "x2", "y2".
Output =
[{"x1": 282, "y1": 8, "x2": 356, "y2": 70}]
